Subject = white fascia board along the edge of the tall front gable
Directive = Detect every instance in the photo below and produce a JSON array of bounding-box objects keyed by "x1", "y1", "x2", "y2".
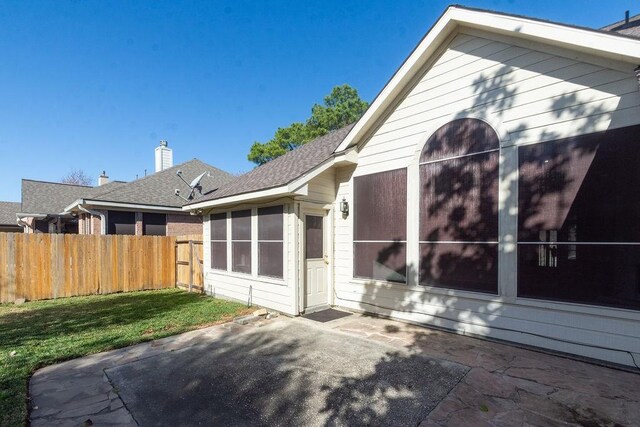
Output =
[{"x1": 336, "y1": 6, "x2": 640, "y2": 152}]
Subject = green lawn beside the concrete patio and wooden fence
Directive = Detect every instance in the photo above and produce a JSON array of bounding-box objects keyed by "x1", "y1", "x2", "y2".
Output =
[{"x1": 0, "y1": 289, "x2": 250, "y2": 426}]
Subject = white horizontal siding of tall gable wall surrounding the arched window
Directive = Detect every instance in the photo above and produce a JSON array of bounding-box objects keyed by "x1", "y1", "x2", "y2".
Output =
[{"x1": 333, "y1": 33, "x2": 640, "y2": 366}]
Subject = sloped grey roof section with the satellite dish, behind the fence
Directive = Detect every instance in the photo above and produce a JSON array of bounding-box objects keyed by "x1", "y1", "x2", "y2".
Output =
[{"x1": 75, "y1": 159, "x2": 234, "y2": 208}]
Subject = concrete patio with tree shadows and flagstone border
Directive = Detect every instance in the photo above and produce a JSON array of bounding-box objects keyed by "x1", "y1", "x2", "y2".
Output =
[{"x1": 30, "y1": 314, "x2": 640, "y2": 426}]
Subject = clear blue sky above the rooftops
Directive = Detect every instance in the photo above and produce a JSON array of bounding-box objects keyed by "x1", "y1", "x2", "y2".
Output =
[{"x1": 0, "y1": 0, "x2": 640, "y2": 201}]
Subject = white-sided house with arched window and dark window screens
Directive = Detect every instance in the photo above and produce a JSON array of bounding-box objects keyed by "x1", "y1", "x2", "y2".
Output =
[{"x1": 184, "y1": 6, "x2": 640, "y2": 366}]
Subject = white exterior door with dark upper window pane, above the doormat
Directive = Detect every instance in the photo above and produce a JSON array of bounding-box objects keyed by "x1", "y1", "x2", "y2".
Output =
[{"x1": 304, "y1": 215, "x2": 329, "y2": 309}]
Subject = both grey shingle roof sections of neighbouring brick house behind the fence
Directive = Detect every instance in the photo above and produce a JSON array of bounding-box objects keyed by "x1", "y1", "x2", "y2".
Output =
[{"x1": 20, "y1": 159, "x2": 234, "y2": 216}]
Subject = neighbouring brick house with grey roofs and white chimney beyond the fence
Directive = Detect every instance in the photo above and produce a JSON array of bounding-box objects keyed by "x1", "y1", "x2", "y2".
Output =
[{"x1": 18, "y1": 141, "x2": 233, "y2": 236}]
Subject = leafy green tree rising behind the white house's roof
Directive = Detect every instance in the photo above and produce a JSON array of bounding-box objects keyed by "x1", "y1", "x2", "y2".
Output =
[{"x1": 247, "y1": 84, "x2": 369, "y2": 165}]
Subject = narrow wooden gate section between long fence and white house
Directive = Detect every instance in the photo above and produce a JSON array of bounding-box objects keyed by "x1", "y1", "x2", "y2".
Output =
[{"x1": 176, "y1": 234, "x2": 204, "y2": 292}]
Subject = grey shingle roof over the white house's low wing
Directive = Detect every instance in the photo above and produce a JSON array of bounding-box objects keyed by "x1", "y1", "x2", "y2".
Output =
[{"x1": 191, "y1": 124, "x2": 353, "y2": 203}]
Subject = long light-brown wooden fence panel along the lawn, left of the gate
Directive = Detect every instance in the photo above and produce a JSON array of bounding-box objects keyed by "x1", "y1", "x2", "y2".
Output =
[{"x1": 0, "y1": 233, "x2": 176, "y2": 303}]
